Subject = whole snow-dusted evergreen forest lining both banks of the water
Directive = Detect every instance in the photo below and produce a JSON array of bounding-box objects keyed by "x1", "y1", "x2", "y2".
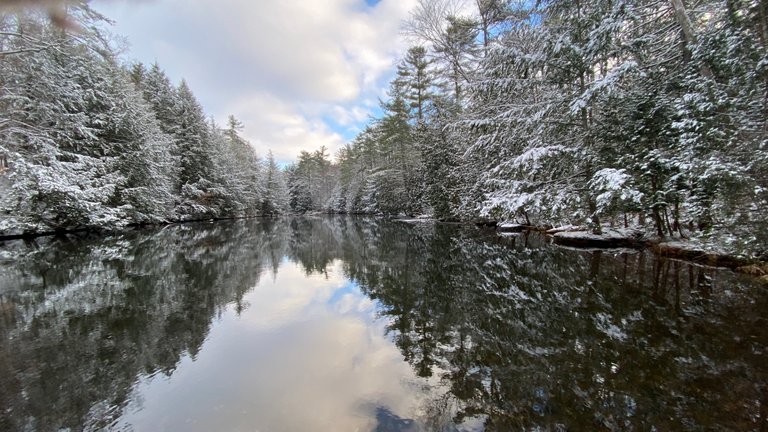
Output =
[{"x1": 0, "y1": 0, "x2": 768, "y2": 255}]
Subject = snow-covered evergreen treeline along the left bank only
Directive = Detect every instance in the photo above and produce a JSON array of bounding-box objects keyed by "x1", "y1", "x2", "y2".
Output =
[{"x1": 0, "y1": 1, "x2": 288, "y2": 235}]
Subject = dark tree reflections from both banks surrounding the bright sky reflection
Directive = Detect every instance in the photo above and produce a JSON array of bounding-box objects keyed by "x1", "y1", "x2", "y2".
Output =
[{"x1": 0, "y1": 218, "x2": 768, "y2": 431}]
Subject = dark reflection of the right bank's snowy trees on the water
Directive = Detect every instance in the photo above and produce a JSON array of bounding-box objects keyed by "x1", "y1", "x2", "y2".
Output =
[{"x1": 314, "y1": 221, "x2": 768, "y2": 430}]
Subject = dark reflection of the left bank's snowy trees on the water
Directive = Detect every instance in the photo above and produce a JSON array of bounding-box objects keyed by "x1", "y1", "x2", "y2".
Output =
[{"x1": 0, "y1": 222, "x2": 287, "y2": 430}]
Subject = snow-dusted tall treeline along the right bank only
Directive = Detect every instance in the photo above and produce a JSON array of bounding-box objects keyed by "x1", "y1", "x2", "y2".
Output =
[{"x1": 290, "y1": 0, "x2": 768, "y2": 255}]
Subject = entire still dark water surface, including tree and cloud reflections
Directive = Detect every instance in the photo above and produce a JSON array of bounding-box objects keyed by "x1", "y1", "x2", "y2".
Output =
[{"x1": 0, "y1": 218, "x2": 768, "y2": 432}]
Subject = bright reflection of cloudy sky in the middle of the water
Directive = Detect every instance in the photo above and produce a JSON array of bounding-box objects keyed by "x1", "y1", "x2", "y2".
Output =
[{"x1": 119, "y1": 262, "x2": 432, "y2": 431}]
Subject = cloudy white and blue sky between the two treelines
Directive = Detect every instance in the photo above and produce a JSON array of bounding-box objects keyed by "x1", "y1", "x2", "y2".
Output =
[{"x1": 92, "y1": 0, "x2": 424, "y2": 164}]
